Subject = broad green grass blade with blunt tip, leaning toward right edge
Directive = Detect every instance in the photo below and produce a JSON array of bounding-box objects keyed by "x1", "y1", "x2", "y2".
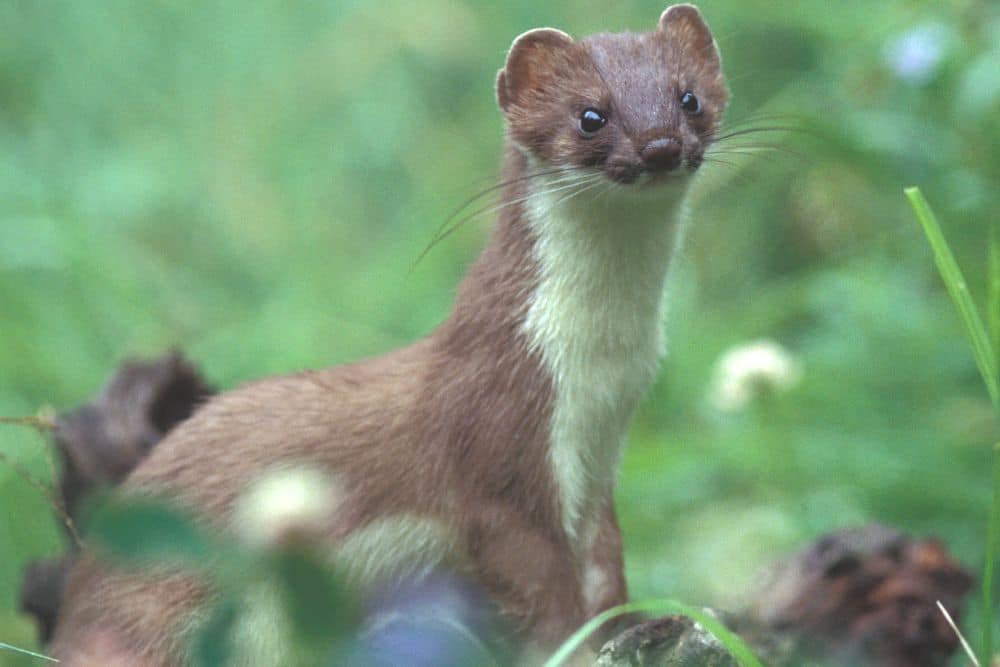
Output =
[{"x1": 904, "y1": 188, "x2": 1000, "y2": 415}]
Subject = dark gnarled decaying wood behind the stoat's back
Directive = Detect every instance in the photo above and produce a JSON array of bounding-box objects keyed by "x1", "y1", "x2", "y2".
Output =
[{"x1": 21, "y1": 352, "x2": 212, "y2": 640}]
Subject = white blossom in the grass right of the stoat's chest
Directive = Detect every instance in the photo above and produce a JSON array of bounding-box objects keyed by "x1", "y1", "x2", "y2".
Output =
[{"x1": 708, "y1": 340, "x2": 802, "y2": 412}]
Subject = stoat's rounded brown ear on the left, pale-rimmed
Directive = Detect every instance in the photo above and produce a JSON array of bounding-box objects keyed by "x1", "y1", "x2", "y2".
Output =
[{"x1": 497, "y1": 28, "x2": 573, "y2": 111}]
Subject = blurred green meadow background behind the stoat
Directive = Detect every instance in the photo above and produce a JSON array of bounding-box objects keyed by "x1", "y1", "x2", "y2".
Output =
[{"x1": 0, "y1": 0, "x2": 1000, "y2": 664}]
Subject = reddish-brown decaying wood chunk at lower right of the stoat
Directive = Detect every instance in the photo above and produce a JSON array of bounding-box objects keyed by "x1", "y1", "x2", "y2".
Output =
[{"x1": 745, "y1": 524, "x2": 972, "y2": 667}]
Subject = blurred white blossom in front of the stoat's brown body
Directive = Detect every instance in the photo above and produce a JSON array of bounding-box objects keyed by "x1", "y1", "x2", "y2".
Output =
[{"x1": 235, "y1": 467, "x2": 340, "y2": 548}]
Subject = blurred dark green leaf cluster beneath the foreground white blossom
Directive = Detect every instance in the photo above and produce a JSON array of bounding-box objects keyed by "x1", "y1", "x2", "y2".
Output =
[{"x1": 85, "y1": 498, "x2": 360, "y2": 667}]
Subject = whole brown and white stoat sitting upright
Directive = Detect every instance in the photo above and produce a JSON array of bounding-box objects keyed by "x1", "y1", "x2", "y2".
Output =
[{"x1": 54, "y1": 5, "x2": 726, "y2": 665}]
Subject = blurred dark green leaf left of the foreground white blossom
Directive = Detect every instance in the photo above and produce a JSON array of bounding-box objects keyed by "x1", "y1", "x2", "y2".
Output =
[{"x1": 87, "y1": 499, "x2": 211, "y2": 563}]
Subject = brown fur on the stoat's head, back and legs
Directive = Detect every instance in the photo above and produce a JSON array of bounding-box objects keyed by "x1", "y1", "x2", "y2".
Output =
[{"x1": 48, "y1": 3, "x2": 725, "y2": 665}]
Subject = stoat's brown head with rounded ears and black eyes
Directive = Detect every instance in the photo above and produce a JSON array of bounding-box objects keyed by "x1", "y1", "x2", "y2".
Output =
[{"x1": 497, "y1": 5, "x2": 727, "y2": 184}]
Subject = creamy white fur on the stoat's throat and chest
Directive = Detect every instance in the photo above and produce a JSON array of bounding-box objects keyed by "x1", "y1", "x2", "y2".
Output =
[{"x1": 524, "y1": 171, "x2": 685, "y2": 543}]
